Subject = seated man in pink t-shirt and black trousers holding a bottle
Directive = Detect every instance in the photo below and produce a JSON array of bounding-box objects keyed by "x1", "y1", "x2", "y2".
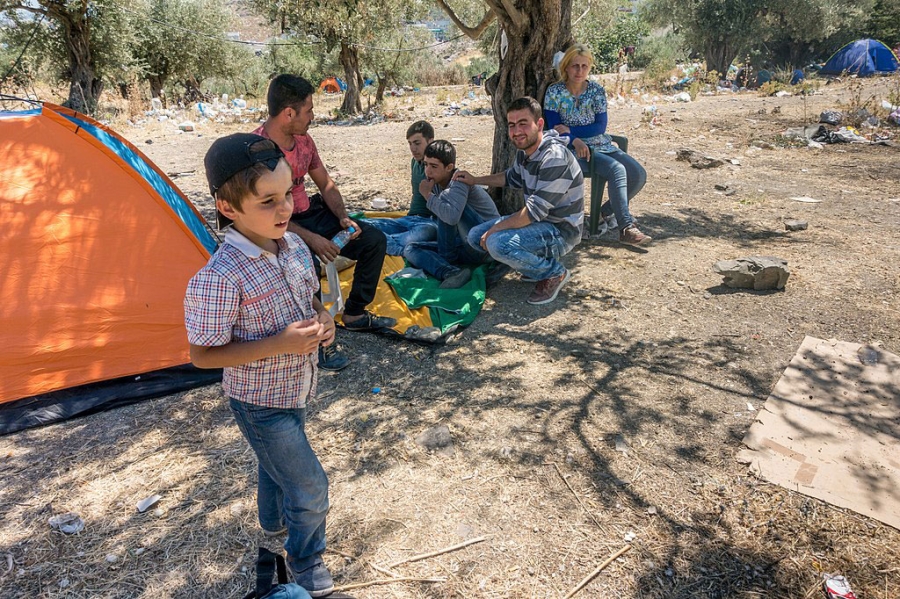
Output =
[{"x1": 253, "y1": 74, "x2": 397, "y2": 370}]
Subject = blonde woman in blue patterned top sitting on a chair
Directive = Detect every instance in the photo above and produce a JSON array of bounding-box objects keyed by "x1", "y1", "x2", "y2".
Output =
[{"x1": 544, "y1": 44, "x2": 651, "y2": 245}]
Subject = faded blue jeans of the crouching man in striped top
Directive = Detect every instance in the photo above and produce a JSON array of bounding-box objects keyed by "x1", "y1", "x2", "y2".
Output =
[{"x1": 469, "y1": 216, "x2": 567, "y2": 281}]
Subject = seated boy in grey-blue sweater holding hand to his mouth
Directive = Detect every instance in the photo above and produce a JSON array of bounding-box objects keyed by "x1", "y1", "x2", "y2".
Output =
[{"x1": 403, "y1": 139, "x2": 500, "y2": 289}]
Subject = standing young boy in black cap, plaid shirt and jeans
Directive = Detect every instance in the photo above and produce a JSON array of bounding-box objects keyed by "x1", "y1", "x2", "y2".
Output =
[{"x1": 184, "y1": 133, "x2": 335, "y2": 597}]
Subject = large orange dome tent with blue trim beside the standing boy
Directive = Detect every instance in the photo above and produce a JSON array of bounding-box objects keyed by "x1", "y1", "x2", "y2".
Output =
[{"x1": 0, "y1": 104, "x2": 221, "y2": 434}]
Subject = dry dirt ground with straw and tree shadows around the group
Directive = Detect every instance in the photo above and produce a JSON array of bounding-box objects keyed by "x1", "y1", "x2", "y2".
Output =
[{"x1": 0, "y1": 81, "x2": 900, "y2": 599}]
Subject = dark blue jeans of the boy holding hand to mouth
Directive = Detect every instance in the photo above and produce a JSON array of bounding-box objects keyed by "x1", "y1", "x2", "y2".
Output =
[{"x1": 403, "y1": 206, "x2": 488, "y2": 281}]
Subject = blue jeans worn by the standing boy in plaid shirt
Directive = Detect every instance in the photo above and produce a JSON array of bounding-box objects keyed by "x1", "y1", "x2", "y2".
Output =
[{"x1": 230, "y1": 399, "x2": 328, "y2": 563}]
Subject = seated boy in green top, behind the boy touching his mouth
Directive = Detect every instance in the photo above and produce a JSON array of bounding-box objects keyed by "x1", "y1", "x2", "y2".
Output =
[{"x1": 366, "y1": 121, "x2": 437, "y2": 256}]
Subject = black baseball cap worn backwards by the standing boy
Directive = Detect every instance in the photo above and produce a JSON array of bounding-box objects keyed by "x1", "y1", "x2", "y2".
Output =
[{"x1": 203, "y1": 133, "x2": 284, "y2": 229}]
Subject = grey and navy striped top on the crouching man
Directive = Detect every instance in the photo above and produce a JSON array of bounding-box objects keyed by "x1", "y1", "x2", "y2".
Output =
[{"x1": 506, "y1": 130, "x2": 584, "y2": 252}]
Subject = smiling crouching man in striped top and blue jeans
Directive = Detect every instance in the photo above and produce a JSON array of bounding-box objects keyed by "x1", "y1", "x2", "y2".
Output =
[{"x1": 453, "y1": 96, "x2": 584, "y2": 304}]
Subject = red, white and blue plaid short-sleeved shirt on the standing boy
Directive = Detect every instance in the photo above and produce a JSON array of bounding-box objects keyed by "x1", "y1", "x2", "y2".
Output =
[{"x1": 184, "y1": 227, "x2": 319, "y2": 409}]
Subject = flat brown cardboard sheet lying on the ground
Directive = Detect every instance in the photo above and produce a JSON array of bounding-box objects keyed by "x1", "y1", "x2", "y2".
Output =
[{"x1": 738, "y1": 337, "x2": 900, "y2": 529}]
